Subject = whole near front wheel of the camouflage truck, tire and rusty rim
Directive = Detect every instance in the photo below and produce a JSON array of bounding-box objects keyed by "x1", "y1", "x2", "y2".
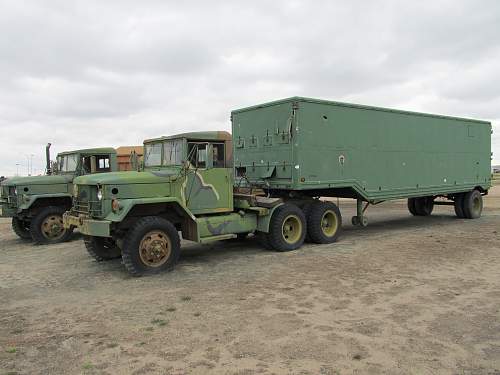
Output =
[{"x1": 122, "y1": 216, "x2": 180, "y2": 276}]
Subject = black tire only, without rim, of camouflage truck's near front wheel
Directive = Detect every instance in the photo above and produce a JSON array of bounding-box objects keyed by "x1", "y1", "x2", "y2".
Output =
[{"x1": 122, "y1": 216, "x2": 181, "y2": 276}]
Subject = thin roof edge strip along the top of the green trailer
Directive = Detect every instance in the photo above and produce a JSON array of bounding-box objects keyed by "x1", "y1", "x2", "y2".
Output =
[{"x1": 231, "y1": 96, "x2": 491, "y2": 124}]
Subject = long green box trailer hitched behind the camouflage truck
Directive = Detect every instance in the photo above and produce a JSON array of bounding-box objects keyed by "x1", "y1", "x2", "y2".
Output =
[{"x1": 231, "y1": 97, "x2": 492, "y2": 225}]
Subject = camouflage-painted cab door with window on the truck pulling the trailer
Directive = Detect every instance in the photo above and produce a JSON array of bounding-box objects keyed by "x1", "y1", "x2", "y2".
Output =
[{"x1": 184, "y1": 142, "x2": 233, "y2": 214}]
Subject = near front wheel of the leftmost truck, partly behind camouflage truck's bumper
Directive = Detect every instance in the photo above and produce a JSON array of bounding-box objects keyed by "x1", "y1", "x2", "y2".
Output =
[{"x1": 30, "y1": 206, "x2": 73, "y2": 244}]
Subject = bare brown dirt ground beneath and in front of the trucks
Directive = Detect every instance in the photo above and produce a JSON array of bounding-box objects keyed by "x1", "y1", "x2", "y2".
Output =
[{"x1": 0, "y1": 186, "x2": 500, "y2": 374}]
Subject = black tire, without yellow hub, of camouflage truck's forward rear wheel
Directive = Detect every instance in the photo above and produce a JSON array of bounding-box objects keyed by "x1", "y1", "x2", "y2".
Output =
[{"x1": 268, "y1": 203, "x2": 307, "y2": 251}]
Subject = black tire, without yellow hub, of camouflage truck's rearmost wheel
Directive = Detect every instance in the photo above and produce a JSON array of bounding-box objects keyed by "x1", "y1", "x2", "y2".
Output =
[{"x1": 307, "y1": 201, "x2": 342, "y2": 244}]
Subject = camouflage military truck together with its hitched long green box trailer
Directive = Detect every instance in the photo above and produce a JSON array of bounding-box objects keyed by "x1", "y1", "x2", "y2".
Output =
[{"x1": 64, "y1": 98, "x2": 491, "y2": 276}]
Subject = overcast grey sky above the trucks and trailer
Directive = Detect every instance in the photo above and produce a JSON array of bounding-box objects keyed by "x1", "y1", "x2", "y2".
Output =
[{"x1": 0, "y1": 0, "x2": 500, "y2": 175}]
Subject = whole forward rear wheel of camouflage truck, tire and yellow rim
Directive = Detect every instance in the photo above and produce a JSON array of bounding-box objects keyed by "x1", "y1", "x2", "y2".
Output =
[{"x1": 268, "y1": 203, "x2": 307, "y2": 251}]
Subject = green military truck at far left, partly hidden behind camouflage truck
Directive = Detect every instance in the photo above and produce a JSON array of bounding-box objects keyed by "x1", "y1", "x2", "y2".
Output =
[{"x1": 0, "y1": 144, "x2": 117, "y2": 244}]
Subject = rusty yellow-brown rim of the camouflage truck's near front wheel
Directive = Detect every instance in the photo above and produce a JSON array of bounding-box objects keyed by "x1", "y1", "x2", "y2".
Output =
[{"x1": 139, "y1": 230, "x2": 172, "y2": 267}]
